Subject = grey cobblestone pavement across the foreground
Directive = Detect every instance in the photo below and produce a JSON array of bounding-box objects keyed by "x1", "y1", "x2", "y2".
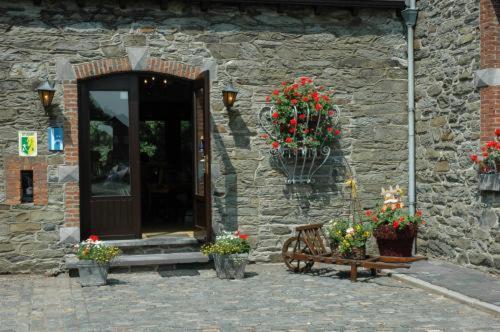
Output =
[{"x1": 0, "y1": 264, "x2": 500, "y2": 331}]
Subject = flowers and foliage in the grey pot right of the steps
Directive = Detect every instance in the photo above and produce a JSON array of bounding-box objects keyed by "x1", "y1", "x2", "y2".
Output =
[{"x1": 201, "y1": 231, "x2": 250, "y2": 256}]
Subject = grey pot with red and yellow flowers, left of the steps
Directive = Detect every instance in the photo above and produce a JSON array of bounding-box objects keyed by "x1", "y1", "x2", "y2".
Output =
[{"x1": 75, "y1": 235, "x2": 121, "y2": 287}]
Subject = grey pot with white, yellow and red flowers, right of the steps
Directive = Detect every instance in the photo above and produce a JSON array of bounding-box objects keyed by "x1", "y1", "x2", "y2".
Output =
[{"x1": 201, "y1": 231, "x2": 250, "y2": 279}]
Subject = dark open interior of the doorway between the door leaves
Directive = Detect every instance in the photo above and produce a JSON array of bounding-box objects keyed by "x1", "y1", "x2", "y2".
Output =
[{"x1": 139, "y1": 74, "x2": 203, "y2": 238}]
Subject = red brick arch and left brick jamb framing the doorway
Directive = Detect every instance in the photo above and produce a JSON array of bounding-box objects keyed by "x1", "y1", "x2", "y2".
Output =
[{"x1": 63, "y1": 56, "x2": 202, "y2": 228}]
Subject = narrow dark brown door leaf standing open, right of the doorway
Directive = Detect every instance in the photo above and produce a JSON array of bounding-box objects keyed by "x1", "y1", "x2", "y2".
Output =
[{"x1": 193, "y1": 71, "x2": 212, "y2": 240}]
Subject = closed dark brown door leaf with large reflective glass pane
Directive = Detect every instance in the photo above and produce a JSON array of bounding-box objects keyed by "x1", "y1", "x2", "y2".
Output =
[{"x1": 79, "y1": 74, "x2": 141, "y2": 239}]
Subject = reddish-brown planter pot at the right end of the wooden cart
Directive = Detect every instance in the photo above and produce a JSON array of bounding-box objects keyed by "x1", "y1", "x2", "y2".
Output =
[{"x1": 373, "y1": 224, "x2": 418, "y2": 257}]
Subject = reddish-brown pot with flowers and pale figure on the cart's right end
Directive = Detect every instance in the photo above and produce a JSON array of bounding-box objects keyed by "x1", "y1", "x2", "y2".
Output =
[{"x1": 364, "y1": 186, "x2": 425, "y2": 257}]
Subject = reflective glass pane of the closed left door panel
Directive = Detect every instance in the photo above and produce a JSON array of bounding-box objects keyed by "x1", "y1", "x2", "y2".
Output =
[{"x1": 89, "y1": 91, "x2": 130, "y2": 196}]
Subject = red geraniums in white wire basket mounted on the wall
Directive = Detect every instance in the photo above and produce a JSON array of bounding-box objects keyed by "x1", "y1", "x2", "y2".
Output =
[{"x1": 259, "y1": 77, "x2": 341, "y2": 183}]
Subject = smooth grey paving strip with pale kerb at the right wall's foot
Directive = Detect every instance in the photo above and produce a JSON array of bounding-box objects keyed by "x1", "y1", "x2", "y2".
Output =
[{"x1": 395, "y1": 260, "x2": 500, "y2": 306}]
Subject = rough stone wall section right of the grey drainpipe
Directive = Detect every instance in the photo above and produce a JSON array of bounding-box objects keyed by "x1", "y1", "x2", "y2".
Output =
[{"x1": 415, "y1": 0, "x2": 500, "y2": 272}]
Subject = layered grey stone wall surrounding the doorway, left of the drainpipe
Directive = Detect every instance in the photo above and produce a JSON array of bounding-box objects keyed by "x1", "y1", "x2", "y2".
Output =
[{"x1": 0, "y1": 1, "x2": 407, "y2": 273}]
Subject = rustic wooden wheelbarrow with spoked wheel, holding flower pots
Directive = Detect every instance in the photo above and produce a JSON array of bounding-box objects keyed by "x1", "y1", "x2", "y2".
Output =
[{"x1": 282, "y1": 224, "x2": 425, "y2": 281}]
